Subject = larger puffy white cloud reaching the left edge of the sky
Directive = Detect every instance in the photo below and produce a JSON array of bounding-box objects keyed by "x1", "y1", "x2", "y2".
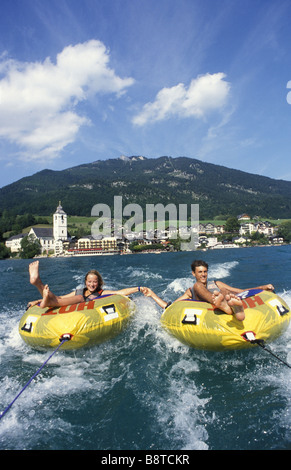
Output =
[{"x1": 0, "y1": 40, "x2": 134, "y2": 160}]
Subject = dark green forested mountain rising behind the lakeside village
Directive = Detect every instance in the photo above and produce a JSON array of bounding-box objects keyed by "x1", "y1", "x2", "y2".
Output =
[{"x1": 0, "y1": 157, "x2": 291, "y2": 220}]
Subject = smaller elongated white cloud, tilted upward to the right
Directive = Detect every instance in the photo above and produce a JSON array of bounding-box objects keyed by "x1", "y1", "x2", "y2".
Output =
[{"x1": 133, "y1": 73, "x2": 230, "y2": 126}]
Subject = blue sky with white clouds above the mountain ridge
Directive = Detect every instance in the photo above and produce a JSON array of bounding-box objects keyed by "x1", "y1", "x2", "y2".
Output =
[{"x1": 0, "y1": 0, "x2": 291, "y2": 187}]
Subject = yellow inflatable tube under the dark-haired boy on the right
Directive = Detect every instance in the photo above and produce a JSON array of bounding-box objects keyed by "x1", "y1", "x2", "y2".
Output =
[{"x1": 161, "y1": 289, "x2": 291, "y2": 351}]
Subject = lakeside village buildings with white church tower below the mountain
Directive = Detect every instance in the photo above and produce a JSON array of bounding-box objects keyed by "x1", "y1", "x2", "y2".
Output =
[{"x1": 5, "y1": 203, "x2": 284, "y2": 256}]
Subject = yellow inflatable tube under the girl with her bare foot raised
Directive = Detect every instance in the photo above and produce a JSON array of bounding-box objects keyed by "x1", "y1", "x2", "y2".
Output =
[{"x1": 19, "y1": 294, "x2": 135, "y2": 349}]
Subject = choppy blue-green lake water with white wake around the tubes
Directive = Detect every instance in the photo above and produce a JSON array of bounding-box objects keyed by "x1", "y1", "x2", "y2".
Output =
[{"x1": 0, "y1": 246, "x2": 291, "y2": 450}]
